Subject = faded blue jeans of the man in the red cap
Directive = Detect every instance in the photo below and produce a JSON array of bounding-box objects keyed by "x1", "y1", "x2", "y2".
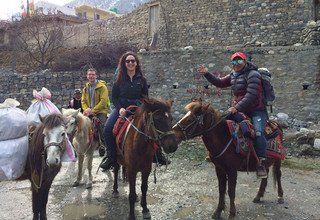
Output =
[{"x1": 248, "y1": 111, "x2": 268, "y2": 158}]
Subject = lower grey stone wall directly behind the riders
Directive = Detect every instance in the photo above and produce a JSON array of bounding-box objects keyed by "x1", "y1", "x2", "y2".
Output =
[{"x1": 0, "y1": 46, "x2": 320, "y2": 121}]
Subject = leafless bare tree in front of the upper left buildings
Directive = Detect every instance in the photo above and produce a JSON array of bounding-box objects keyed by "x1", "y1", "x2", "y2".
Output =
[{"x1": 11, "y1": 14, "x2": 74, "y2": 70}]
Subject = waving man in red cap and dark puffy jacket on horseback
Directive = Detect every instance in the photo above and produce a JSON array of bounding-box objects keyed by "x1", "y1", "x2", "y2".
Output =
[{"x1": 198, "y1": 52, "x2": 268, "y2": 178}]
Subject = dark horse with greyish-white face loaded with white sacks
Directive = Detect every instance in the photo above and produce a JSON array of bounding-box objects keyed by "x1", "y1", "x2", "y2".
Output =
[{"x1": 26, "y1": 113, "x2": 67, "y2": 220}]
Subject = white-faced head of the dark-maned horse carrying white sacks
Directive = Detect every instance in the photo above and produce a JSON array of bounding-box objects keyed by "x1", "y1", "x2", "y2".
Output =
[{"x1": 31, "y1": 114, "x2": 67, "y2": 166}]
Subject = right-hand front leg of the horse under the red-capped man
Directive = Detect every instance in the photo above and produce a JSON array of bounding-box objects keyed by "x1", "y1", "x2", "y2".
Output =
[{"x1": 228, "y1": 169, "x2": 238, "y2": 219}]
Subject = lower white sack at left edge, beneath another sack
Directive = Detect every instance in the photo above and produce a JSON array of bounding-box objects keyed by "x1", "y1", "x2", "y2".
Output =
[{"x1": 0, "y1": 135, "x2": 28, "y2": 181}]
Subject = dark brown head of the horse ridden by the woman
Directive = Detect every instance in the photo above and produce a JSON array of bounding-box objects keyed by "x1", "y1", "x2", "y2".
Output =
[{"x1": 141, "y1": 99, "x2": 178, "y2": 153}]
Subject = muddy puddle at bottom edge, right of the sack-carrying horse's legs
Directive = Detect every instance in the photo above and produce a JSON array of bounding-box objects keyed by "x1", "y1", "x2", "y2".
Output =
[{"x1": 62, "y1": 204, "x2": 106, "y2": 220}]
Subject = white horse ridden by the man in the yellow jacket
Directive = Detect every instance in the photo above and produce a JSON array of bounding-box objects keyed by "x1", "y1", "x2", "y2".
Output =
[{"x1": 62, "y1": 108, "x2": 99, "y2": 189}]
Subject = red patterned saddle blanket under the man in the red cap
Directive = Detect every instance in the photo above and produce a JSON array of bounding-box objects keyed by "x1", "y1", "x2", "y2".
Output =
[{"x1": 226, "y1": 113, "x2": 285, "y2": 160}]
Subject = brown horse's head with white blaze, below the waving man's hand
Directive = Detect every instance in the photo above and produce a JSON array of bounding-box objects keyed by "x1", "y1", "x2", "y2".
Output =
[{"x1": 173, "y1": 99, "x2": 220, "y2": 142}]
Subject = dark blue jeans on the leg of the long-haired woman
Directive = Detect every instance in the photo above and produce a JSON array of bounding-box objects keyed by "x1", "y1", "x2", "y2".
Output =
[{"x1": 103, "y1": 109, "x2": 119, "y2": 157}]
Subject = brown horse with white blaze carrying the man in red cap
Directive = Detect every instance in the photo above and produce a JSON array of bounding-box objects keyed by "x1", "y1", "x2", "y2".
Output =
[{"x1": 173, "y1": 100, "x2": 283, "y2": 219}]
